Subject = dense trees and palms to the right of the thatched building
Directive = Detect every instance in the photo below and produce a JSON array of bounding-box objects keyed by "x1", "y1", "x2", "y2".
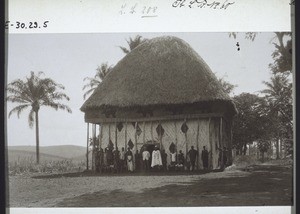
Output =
[{"x1": 229, "y1": 32, "x2": 293, "y2": 159}]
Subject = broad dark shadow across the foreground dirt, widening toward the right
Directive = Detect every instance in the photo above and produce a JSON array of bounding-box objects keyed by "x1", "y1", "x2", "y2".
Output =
[{"x1": 56, "y1": 165, "x2": 293, "y2": 207}]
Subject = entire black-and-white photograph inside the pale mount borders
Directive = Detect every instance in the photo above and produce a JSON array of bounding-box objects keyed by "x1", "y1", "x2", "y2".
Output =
[{"x1": 6, "y1": 31, "x2": 295, "y2": 208}]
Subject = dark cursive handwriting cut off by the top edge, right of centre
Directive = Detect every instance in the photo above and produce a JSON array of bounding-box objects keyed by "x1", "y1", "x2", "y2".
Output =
[{"x1": 172, "y1": 0, "x2": 235, "y2": 10}]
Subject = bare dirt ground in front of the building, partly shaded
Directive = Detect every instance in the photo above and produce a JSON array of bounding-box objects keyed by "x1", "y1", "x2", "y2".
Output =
[{"x1": 10, "y1": 165, "x2": 292, "y2": 207}]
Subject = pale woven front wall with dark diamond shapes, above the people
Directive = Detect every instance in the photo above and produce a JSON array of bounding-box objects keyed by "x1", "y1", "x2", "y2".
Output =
[{"x1": 97, "y1": 119, "x2": 221, "y2": 169}]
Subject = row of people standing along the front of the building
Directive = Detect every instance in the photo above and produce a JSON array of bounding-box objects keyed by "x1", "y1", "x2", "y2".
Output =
[{"x1": 94, "y1": 146, "x2": 213, "y2": 173}]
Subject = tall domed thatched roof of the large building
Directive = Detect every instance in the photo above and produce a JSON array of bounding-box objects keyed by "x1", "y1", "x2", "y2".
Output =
[{"x1": 81, "y1": 36, "x2": 235, "y2": 111}]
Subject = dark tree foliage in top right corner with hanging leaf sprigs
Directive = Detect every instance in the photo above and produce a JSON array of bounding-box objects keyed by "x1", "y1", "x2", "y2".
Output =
[{"x1": 229, "y1": 32, "x2": 292, "y2": 74}]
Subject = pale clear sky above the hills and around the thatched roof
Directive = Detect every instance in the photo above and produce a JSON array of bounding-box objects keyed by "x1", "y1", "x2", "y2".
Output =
[{"x1": 7, "y1": 32, "x2": 274, "y2": 146}]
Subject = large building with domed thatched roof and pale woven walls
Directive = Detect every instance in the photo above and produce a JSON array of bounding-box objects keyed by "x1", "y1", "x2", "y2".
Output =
[{"x1": 81, "y1": 36, "x2": 236, "y2": 171}]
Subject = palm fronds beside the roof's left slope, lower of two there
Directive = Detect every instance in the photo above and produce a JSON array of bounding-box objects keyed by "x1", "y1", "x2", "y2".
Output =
[{"x1": 82, "y1": 62, "x2": 112, "y2": 99}]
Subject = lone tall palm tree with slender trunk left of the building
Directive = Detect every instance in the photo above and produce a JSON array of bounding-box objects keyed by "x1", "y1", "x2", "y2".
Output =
[{"x1": 6, "y1": 71, "x2": 72, "y2": 164}]
